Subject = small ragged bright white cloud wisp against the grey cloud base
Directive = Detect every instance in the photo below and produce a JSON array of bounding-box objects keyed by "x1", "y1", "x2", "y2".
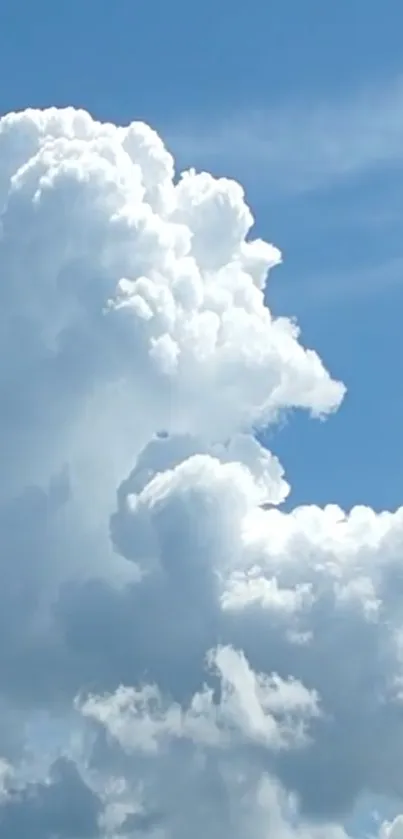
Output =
[{"x1": 81, "y1": 647, "x2": 319, "y2": 752}]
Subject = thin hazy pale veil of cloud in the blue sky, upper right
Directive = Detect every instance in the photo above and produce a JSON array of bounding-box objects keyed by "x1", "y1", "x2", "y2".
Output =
[{"x1": 168, "y1": 78, "x2": 403, "y2": 194}]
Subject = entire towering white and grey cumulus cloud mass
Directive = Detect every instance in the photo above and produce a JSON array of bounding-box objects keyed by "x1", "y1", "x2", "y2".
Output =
[{"x1": 0, "y1": 109, "x2": 403, "y2": 839}]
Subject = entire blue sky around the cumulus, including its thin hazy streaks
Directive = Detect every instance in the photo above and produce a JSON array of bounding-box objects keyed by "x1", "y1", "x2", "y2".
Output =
[{"x1": 0, "y1": 0, "x2": 403, "y2": 508}]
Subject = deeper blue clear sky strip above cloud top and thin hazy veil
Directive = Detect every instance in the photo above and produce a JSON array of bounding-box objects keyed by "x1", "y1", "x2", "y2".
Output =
[{"x1": 0, "y1": 0, "x2": 403, "y2": 118}]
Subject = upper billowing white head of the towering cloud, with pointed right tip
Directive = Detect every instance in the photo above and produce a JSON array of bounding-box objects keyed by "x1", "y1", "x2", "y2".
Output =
[{"x1": 0, "y1": 109, "x2": 343, "y2": 498}]
